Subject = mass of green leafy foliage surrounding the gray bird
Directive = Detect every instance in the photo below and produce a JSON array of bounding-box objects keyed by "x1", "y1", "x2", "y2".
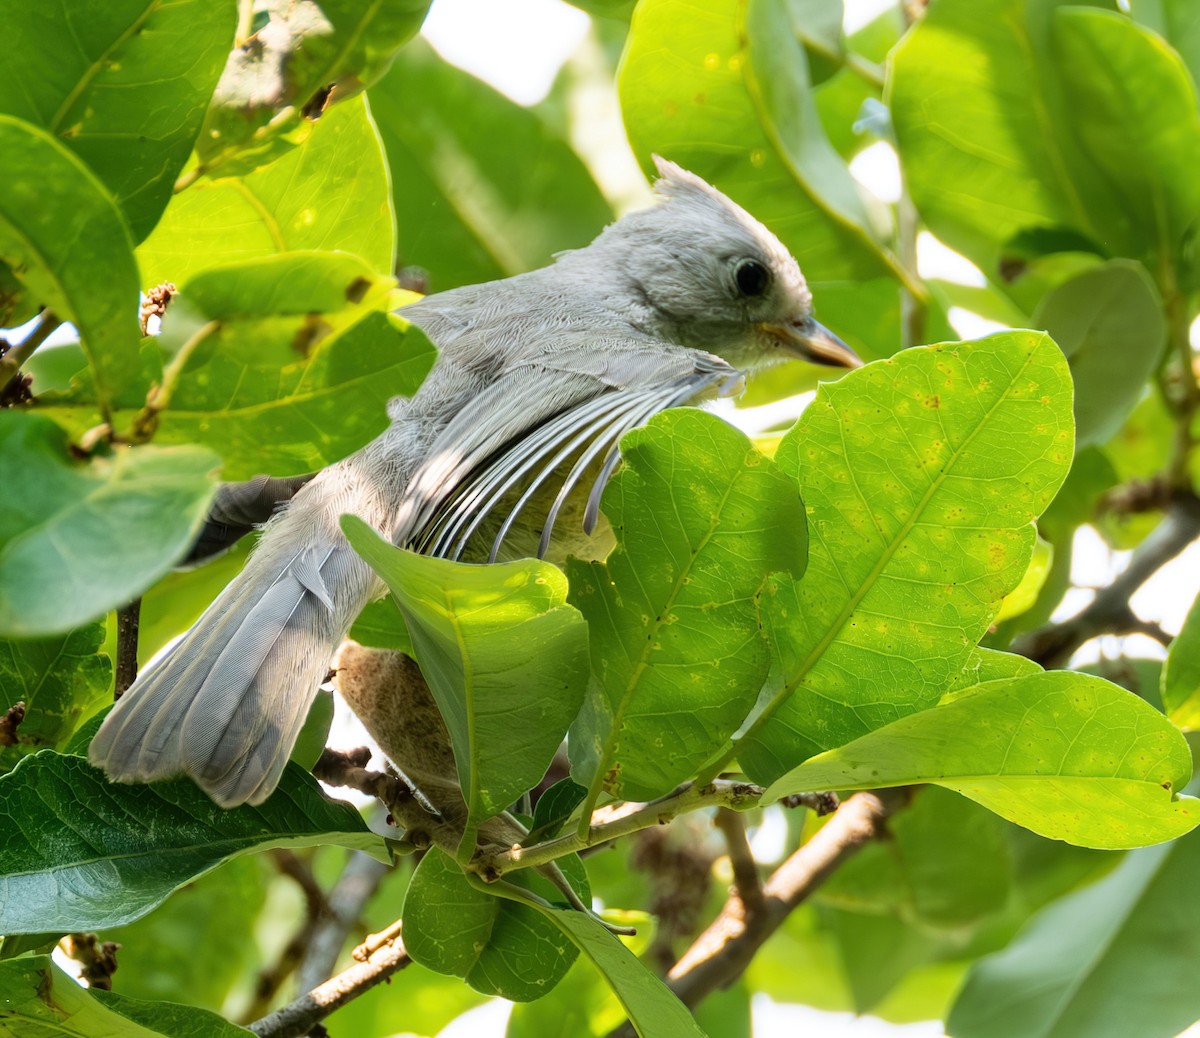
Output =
[{"x1": 0, "y1": 0, "x2": 1200, "y2": 1038}]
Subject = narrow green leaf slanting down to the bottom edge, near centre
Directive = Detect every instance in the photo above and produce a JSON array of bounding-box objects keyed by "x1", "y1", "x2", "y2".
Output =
[{"x1": 492, "y1": 892, "x2": 704, "y2": 1038}]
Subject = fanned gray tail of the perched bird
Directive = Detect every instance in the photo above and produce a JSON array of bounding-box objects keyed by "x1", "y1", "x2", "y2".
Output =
[{"x1": 89, "y1": 458, "x2": 395, "y2": 808}]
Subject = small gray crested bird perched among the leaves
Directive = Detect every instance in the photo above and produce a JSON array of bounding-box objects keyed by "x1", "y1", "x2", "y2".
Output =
[{"x1": 89, "y1": 156, "x2": 862, "y2": 808}]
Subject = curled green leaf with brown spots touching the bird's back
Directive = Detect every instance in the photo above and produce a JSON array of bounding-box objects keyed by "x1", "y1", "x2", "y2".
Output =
[{"x1": 143, "y1": 252, "x2": 434, "y2": 479}]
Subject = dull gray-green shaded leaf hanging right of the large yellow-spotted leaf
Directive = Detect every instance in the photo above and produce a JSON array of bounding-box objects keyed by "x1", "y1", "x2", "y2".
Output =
[{"x1": 1033, "y1": 259, "x2": 1166, "y2": 449}]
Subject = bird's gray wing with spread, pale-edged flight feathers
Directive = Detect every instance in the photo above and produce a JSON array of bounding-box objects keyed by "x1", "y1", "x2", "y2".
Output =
[{"x1": 396, "y1": 340, "x2": 743, "y2": 562}]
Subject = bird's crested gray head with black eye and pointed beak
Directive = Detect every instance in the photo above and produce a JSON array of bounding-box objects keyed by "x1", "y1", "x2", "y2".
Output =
[{"x1": 583, "y1": 156, "x2": 862, "y2": 368}]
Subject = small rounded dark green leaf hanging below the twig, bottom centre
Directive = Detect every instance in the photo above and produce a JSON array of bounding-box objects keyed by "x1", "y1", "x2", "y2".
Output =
[{"x1": 403, "y1": 847, "x2": 590, "y2": 1002}]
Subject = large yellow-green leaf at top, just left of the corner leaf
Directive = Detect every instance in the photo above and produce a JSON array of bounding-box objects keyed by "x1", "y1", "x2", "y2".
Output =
[{"x1": 889, "y1": 0, "x2": 1123, "y2": 275}]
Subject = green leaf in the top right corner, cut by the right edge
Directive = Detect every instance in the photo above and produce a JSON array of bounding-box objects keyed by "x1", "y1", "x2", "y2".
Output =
[{"x1": 1051, "y1": 7, "x2": 1200, "y2": 283}]
